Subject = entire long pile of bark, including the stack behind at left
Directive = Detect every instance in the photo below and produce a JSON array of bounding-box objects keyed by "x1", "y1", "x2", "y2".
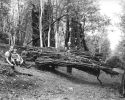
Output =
[{"x1": 21, "y1": 47, "x2": 122, "y2": 75}]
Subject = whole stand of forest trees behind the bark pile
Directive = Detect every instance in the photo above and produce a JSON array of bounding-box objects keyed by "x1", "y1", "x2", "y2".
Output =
[{"x1": 0, "y1": 0, "x2": 110, "y2": 59}]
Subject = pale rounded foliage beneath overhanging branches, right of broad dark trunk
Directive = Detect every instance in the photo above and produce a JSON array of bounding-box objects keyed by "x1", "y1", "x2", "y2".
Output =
[{"x1": 86, "y1": 33, "x2": 111, "y2": 60}]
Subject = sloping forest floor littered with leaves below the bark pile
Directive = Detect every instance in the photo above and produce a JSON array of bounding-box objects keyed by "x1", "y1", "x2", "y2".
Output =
[{"x1": 0, "y1": 46, "x2": 125, "y2": 100}]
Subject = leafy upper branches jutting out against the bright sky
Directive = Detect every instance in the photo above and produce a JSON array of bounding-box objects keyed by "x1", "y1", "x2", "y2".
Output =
[{"x1": 72, "y1": 0, "x2": 110, "y2": 33}]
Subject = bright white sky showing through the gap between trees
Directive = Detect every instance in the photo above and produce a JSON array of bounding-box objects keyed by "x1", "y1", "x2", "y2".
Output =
[{"x1": 100, "y1": 0, "x2": 122, "y2": 51}]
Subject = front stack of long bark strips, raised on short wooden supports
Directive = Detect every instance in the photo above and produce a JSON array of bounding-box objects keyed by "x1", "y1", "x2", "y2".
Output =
[{"x1": 35, "y1": 50, "x2": 114, "y2": 74}]
